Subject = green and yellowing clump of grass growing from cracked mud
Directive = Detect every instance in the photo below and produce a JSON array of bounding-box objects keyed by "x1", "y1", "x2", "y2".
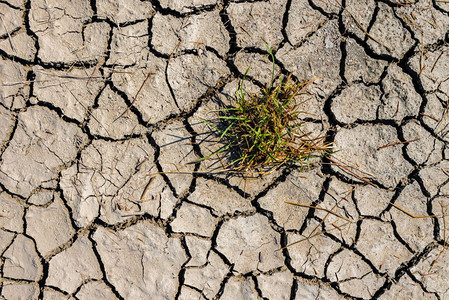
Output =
[{"x1": 198, "y1": 45, "x2": 331, "y2": 171}]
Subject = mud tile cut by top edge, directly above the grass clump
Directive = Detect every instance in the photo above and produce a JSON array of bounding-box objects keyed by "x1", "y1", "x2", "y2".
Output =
[{"x1": 227, "y1": 0, "x2": 287, "y2": 50}]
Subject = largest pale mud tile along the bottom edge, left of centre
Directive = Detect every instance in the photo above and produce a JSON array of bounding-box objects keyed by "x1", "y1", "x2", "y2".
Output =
[{"x1": 93, "y1": 222, "x2": 187, "y2": 299}]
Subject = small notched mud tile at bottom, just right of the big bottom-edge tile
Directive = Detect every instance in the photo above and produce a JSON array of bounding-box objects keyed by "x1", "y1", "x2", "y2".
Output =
[{"x1": 184, "y1": 251, "x2": 229, "y2": 299}]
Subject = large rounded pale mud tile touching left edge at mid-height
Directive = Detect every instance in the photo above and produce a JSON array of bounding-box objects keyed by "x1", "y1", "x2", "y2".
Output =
[{"x1": 0, "y1": 107, "x2": 86, "y2": 197}]
